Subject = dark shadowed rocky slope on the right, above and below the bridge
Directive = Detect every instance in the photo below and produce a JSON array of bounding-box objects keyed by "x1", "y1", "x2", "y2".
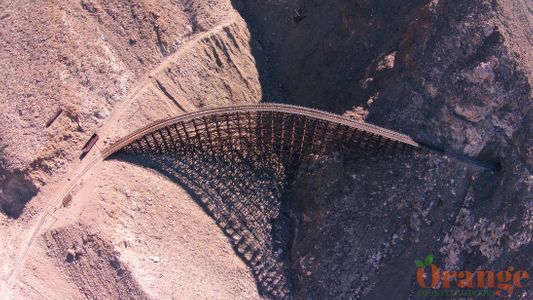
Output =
[{"x1": 235, "y1": 0, "x2": 533, "y2": 299}]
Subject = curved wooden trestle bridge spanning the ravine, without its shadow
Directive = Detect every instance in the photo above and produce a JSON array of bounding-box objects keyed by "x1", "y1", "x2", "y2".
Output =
[{"x1": 103, "y1": 104, "x2": 420, "y2": 163}]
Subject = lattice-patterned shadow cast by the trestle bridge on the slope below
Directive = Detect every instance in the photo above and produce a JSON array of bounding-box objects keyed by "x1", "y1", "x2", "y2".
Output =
[{"x1": 115, "y1": 152, "x2": 292, "y2": 298}]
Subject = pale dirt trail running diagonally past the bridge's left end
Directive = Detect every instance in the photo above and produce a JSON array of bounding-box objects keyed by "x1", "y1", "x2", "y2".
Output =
[{"x1": 0, "y1": 15, "x2": 242, "y2": 299}]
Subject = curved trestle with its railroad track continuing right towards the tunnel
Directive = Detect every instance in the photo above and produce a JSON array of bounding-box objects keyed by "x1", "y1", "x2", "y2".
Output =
[{"x1": 102, "y1": 103, "x2": 502, "y2": 171}]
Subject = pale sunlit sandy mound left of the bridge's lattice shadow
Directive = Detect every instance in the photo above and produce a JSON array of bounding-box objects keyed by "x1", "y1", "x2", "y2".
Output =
[{"x1": 14, "y1": 160, "x2": 258, "y2": 299}]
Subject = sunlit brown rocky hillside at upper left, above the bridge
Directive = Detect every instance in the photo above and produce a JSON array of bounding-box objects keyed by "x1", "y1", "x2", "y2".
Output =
[{"x1": 0, "y1": 1, "x2": 257, "y2": 217}]
